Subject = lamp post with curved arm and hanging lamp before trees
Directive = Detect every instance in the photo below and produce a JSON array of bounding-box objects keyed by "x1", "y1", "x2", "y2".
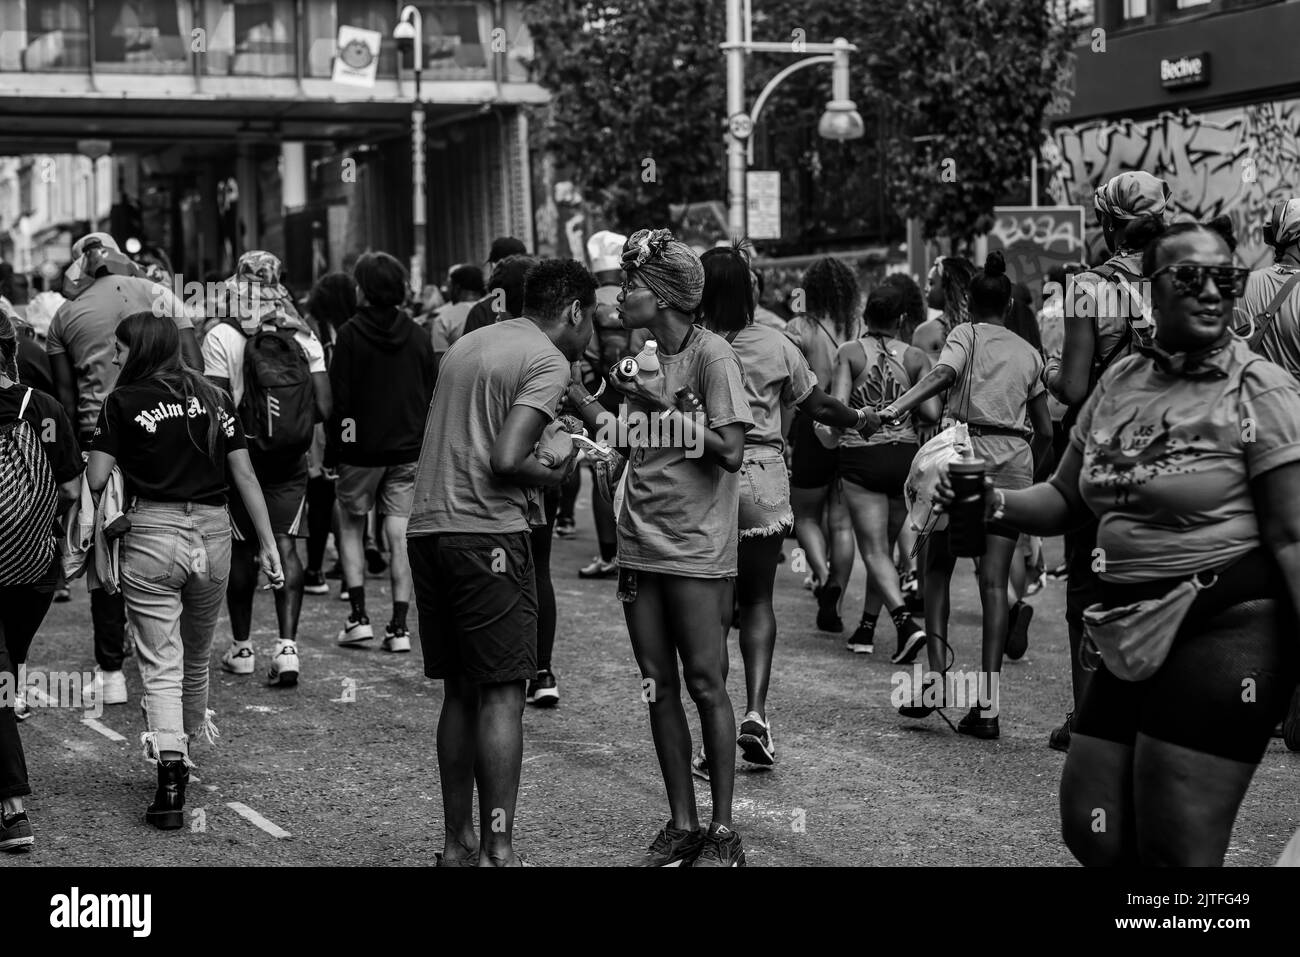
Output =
[{"x1": 722, "y1": 0, "x2": 866, "y2": 237}]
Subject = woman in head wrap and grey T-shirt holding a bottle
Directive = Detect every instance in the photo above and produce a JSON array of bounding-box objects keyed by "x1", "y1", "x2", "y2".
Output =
[{"x1": 569, "y1": 229, "x2": 753, "y2": 867}]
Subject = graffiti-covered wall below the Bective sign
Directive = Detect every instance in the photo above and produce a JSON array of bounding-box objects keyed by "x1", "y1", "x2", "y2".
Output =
[{"x1": 1043, "y1": 100, "x2": 1300, "y2": 268}]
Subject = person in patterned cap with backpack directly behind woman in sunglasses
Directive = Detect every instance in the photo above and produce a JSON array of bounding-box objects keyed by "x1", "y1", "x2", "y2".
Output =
[{"x1": 1044, "y1": 170, "x2": 1170, "y2": 750}]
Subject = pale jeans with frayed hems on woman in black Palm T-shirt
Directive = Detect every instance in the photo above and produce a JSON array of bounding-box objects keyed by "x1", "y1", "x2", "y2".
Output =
[{"x1": 121, "y1": 499, "x2": 230, "y2": 763}]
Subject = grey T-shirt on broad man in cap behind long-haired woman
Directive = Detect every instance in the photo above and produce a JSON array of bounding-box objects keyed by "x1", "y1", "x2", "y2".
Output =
[{"x1": 46, "y1": 276, "x2": 194, "y2": 436}]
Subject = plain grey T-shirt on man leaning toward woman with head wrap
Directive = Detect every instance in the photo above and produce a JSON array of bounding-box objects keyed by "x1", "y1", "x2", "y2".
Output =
[{"x1": 407, "y1": 319, "x2": 569, "y2": 536}]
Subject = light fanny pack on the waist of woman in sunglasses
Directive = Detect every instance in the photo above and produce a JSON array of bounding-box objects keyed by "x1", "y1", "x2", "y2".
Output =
[{"x1": 1083, "y1": 573, "x2": 1218, "y2": 681}]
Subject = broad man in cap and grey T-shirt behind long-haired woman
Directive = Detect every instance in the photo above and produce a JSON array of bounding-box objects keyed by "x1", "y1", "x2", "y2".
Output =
[{"x1": 46, "y1": 233, "x2": 203, "y2": 705}]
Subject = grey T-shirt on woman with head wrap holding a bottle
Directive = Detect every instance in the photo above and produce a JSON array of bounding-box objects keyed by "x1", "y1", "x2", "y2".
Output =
[{"x1": 619, "y1": 326, "x2": 754, "y2": 579}]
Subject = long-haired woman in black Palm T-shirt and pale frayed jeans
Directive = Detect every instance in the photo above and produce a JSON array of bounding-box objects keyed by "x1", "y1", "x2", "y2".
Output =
[{"x1": 87, "y1": 312, "x2": 283, "y2": 830}]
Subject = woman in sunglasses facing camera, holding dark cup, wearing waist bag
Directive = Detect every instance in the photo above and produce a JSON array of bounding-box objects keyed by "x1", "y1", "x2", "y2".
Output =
[{"x1": 943, "y1": 224, "x2": 1300, "y2": 866}]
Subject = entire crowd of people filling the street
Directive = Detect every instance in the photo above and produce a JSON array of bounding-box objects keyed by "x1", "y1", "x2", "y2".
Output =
[{"x1": 0, "y1": 172, "x2": 1300, "y2": 866}]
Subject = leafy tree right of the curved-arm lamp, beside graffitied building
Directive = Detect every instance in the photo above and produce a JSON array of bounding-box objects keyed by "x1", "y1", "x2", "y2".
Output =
[{"x1": 866, "y1": 0, "x2": 1074, "y2": 243}]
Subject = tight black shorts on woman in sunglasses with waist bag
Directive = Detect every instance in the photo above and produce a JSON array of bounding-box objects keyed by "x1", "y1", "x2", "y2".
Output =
[{"x1": 1074, "y1": 549, "x2": 1300, "y2": 765}]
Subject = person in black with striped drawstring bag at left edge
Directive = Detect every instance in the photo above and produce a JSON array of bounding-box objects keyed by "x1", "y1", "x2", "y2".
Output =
[{"x1": 0, "y1": 312, "x2": 82, "y2": 852}]
